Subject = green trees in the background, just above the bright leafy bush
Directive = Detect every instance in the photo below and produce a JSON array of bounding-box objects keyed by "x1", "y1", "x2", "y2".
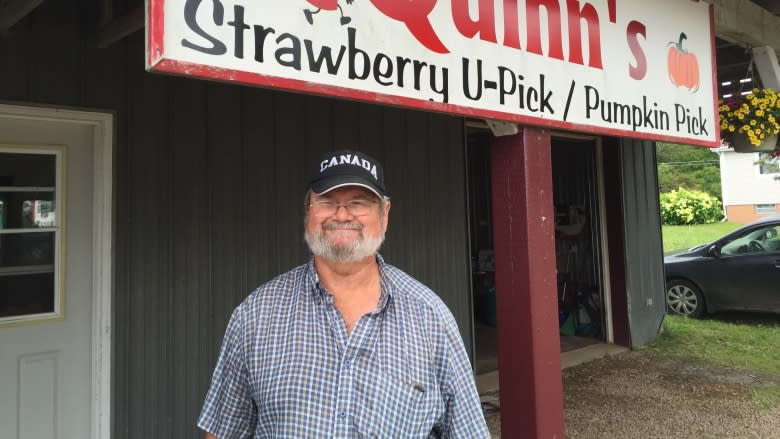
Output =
[{"x1": 656, "y1": 142, "x2": 722, "y2": 199}]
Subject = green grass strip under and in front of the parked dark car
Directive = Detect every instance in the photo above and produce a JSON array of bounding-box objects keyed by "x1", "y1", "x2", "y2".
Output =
[{"x1": 644, "y1": 313, "x2": 780, "y2": 407}]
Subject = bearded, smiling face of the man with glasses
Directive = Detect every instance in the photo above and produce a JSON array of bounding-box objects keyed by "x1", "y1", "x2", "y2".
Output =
[{"x1": 305, "y1": 186, "x2": 390, "y2": 263}]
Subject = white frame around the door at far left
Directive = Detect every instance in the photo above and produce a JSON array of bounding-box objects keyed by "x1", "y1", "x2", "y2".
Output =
[{"x1": 0, "y1": 103, "x2": 114, "y2": 439}]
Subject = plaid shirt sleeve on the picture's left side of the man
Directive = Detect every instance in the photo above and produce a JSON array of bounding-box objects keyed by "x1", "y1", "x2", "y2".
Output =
[{"x1": 198, "y1": 307, "x2": 257, "y2": 439}]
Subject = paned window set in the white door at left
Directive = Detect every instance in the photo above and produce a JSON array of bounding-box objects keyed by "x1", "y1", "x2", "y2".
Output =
[{"x1": 0, "y1": 145, "x2": 64, "y2": 324}]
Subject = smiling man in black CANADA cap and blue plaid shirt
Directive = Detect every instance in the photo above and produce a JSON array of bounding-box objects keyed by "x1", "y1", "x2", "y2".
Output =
[{"x1": 198, "y1": 151, "x2": 489, "y2": 439}]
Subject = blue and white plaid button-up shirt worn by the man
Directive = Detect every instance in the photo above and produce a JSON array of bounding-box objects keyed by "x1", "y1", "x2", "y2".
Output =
[{"x1": 198, "y1": 256, "x2": 490, "y2": 439}]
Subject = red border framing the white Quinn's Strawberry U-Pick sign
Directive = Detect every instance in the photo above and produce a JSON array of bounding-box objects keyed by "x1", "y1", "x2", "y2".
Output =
[{"x1": 146, "y1": 0, "x2": 721, "y2": 148}]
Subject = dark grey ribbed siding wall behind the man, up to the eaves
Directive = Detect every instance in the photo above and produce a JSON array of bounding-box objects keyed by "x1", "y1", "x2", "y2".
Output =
[{"x1": 0, "y1": 1, "x2": 472, "y2": 439}]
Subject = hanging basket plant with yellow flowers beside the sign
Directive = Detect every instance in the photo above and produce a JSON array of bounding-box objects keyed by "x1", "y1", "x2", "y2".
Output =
[{"x1": 718, "y1": 88, "x2": 780, "y2": 150}]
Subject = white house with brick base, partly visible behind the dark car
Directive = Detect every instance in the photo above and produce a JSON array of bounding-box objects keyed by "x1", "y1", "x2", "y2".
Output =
[{"x1": 716, "y1": 148, "x2": 780, "y2": 224}]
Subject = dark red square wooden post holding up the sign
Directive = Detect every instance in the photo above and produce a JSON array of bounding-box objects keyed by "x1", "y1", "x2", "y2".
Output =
[{"x1": 490, "y1": 128, "x2": 564, "y2": 439}]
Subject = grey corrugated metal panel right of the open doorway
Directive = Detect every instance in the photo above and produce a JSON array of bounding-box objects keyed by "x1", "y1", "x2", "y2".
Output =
[{"x1": 620, "y1": 139, "x2": 666, "y2": 346}]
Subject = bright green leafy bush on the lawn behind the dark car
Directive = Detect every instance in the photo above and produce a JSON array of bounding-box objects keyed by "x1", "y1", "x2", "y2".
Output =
[{"x1": 660, "y1": 188, "x2": 723, "y2": 225}]
